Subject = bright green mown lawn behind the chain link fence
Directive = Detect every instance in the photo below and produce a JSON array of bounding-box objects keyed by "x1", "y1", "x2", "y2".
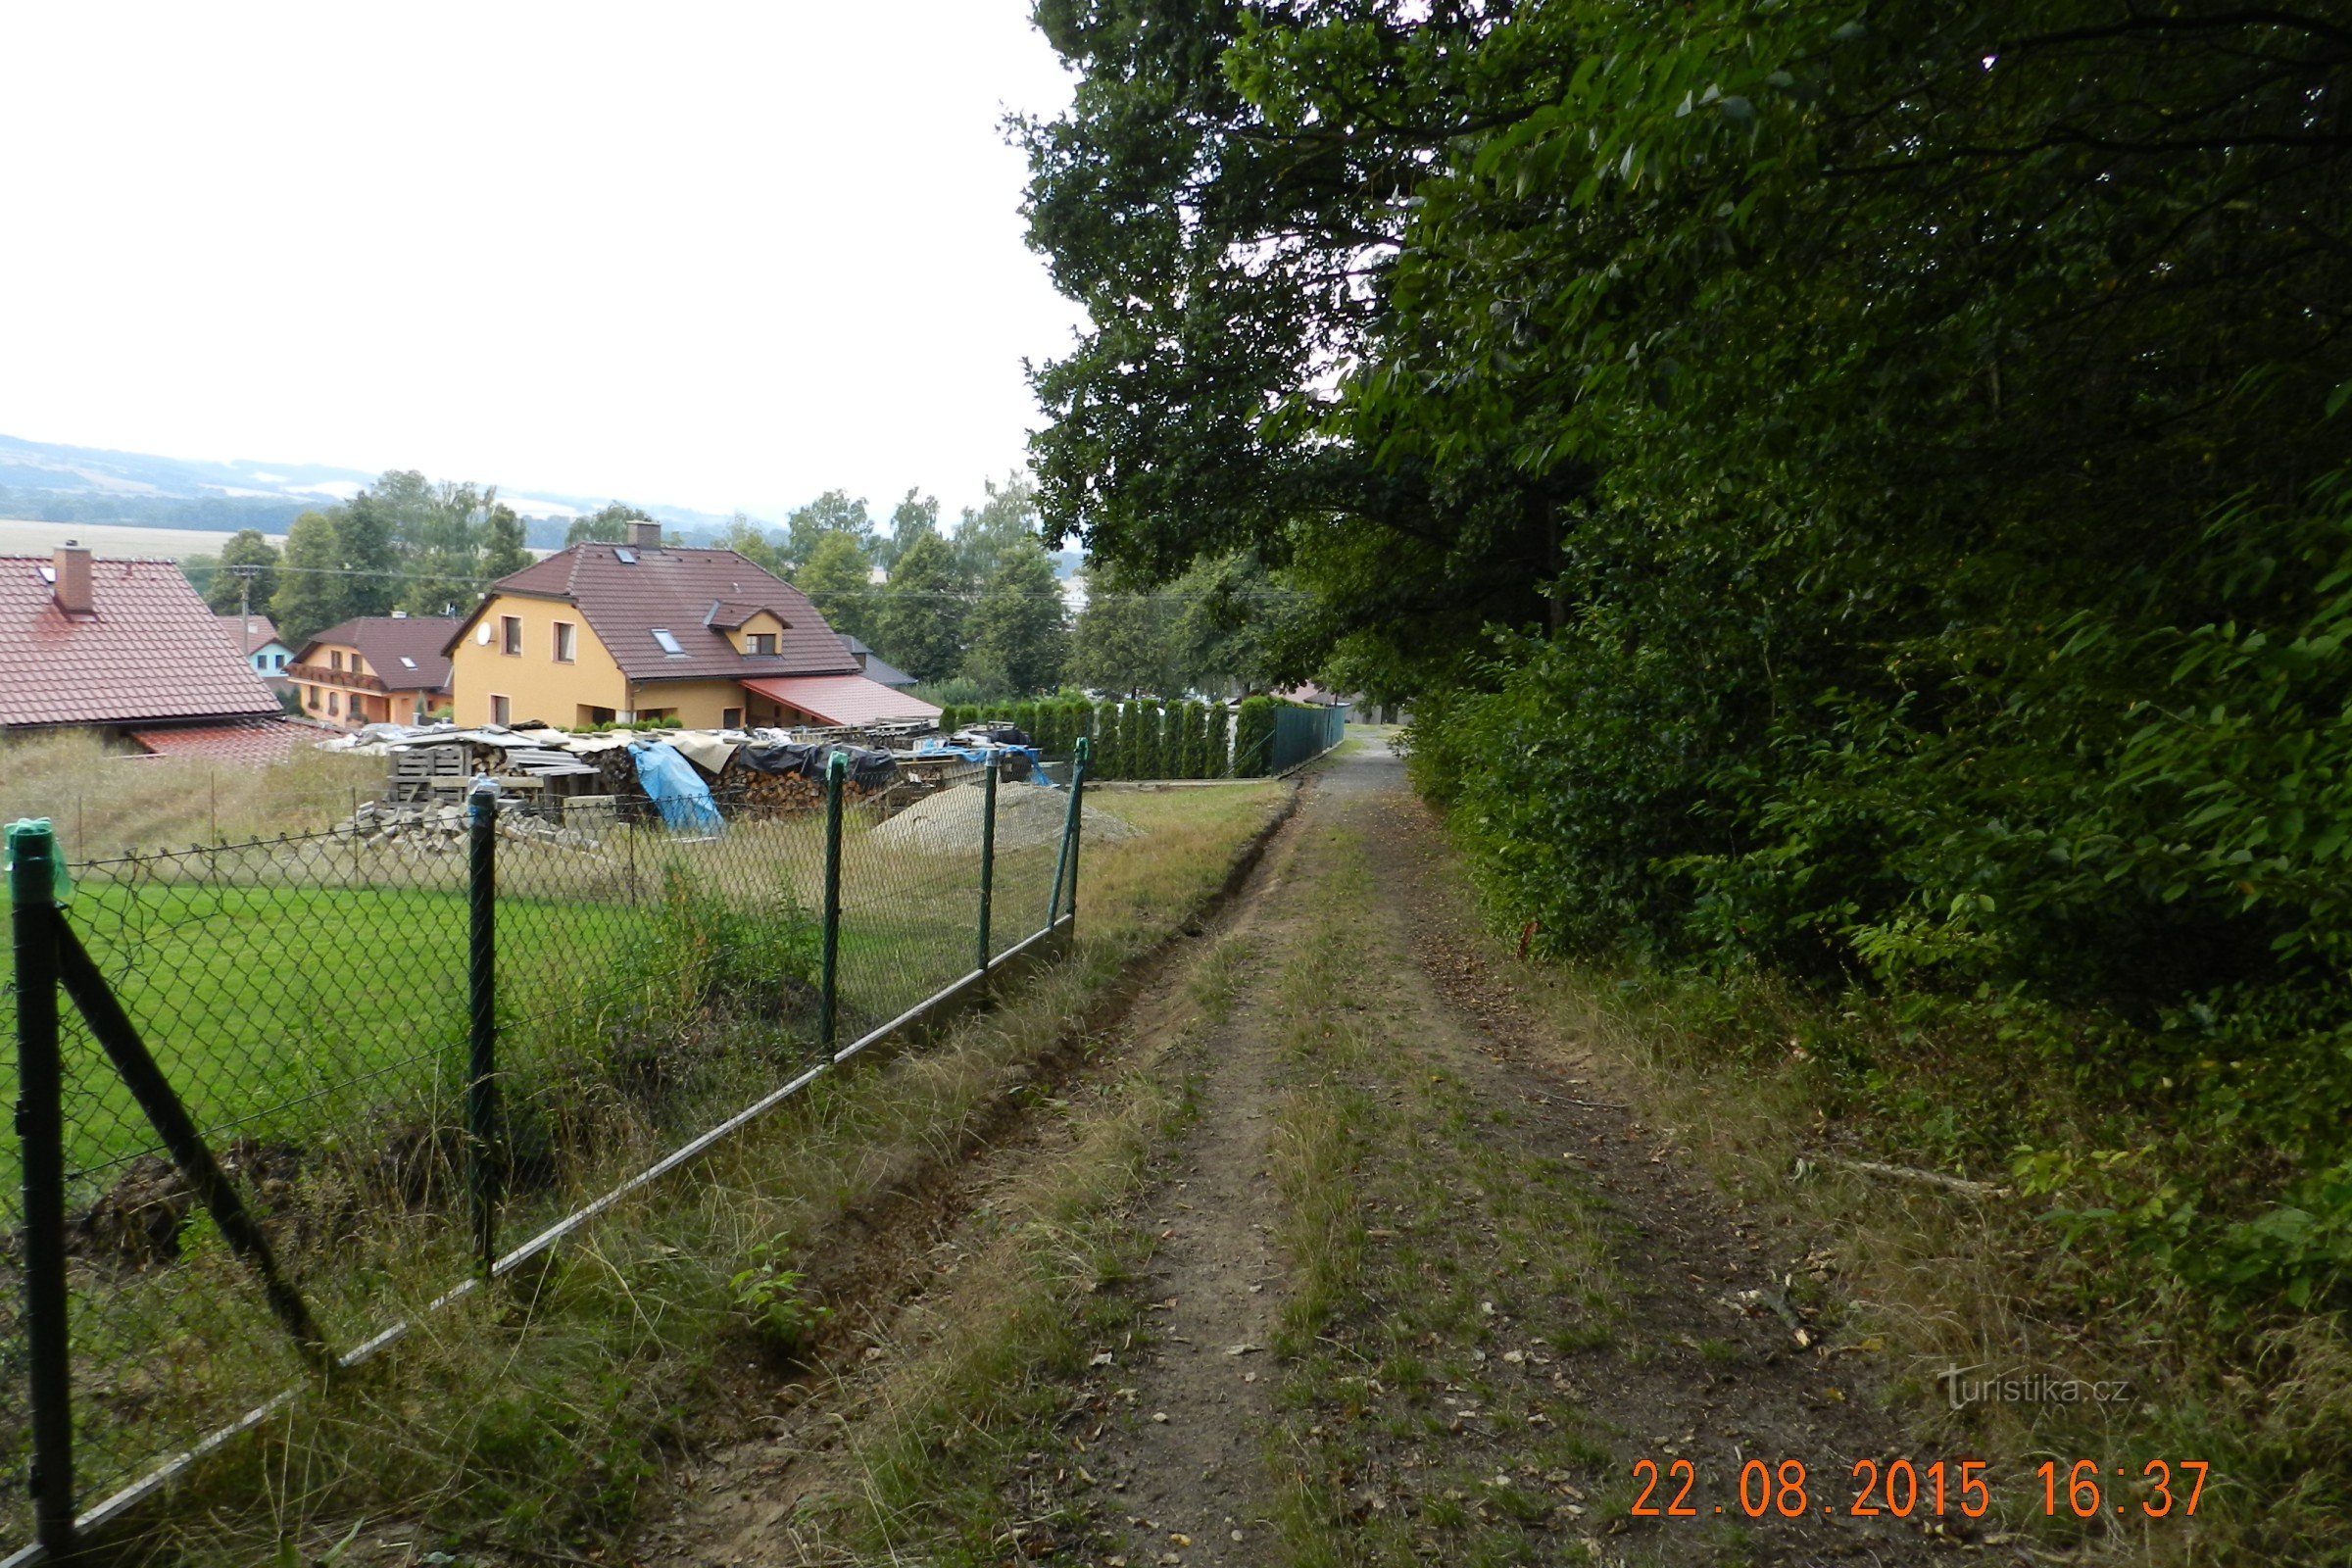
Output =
[{"x1": 0, "y1": 820, "x2": 1077, "y2": 1203}]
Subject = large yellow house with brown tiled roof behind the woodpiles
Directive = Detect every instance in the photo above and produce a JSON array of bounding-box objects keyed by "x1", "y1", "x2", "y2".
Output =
[{"x1": 445, "y1": 524, "x2": 939, "y2": 729}]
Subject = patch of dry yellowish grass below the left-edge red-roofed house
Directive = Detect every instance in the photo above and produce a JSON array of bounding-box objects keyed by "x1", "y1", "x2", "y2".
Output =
[{"x1": 0, "y1": 731, "x2": 383, "y2": 860}]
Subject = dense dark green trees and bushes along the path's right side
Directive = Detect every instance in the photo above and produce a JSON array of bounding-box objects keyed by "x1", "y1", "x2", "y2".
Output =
[{"x1": 1028, "y1": 0, "x2": 2352, "y2": 1309}]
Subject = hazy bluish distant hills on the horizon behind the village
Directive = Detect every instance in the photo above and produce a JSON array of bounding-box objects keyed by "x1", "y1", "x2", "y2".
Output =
[{"x1": 0, "y1": 435, "x2": 727, "y2": 548}]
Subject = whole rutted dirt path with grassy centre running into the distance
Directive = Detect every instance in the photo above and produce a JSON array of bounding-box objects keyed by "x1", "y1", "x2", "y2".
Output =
[{"x1": 637, "y1": 743, "x2": 1964, "y2": 1568}]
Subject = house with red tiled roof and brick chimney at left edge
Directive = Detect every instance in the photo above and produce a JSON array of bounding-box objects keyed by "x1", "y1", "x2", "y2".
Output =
[{"x1": 0, "y1": 543, "x2": 306, "y2": 761}]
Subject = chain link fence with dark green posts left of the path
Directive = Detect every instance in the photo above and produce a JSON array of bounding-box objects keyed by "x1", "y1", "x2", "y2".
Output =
[{"x1": 0, "y1": 750, "x2": 1087, "y2": 1556}]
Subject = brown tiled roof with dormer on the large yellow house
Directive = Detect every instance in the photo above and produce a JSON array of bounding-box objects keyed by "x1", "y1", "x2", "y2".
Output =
[{"x1": 442, "y1": 546, "x2": 858, "y2": 682}]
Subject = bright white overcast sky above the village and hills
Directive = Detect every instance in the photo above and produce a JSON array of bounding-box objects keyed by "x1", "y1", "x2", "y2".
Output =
[{"x1": 0, "y1": 0, "x2": 1080, "y2": 517}]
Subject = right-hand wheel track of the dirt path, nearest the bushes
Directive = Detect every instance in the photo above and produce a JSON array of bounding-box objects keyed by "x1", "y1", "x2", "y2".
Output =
[{"x1": 1289, "y1": 752, "x2": 1966, "y2": 1563}]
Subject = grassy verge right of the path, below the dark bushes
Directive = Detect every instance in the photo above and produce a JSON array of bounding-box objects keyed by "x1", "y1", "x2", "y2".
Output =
[{"x1": 1420, "y1": 822, "x2": 2352, "y2": 1568}]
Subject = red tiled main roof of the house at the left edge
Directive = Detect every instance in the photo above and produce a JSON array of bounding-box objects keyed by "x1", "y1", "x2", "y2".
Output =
[{"x1": 0, "y1": 555, "x2": 280, "y2": 726}]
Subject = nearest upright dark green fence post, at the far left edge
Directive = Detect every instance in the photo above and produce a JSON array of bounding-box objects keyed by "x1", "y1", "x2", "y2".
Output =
[{"x1": 7, "y1": 818, "x2": 73, "y2": 1556}]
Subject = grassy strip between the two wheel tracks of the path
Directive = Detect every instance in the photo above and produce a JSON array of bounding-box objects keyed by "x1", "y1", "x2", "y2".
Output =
[{"x1": 1270, "y1": 832, "x2": 1623, "y2": 1568}]
